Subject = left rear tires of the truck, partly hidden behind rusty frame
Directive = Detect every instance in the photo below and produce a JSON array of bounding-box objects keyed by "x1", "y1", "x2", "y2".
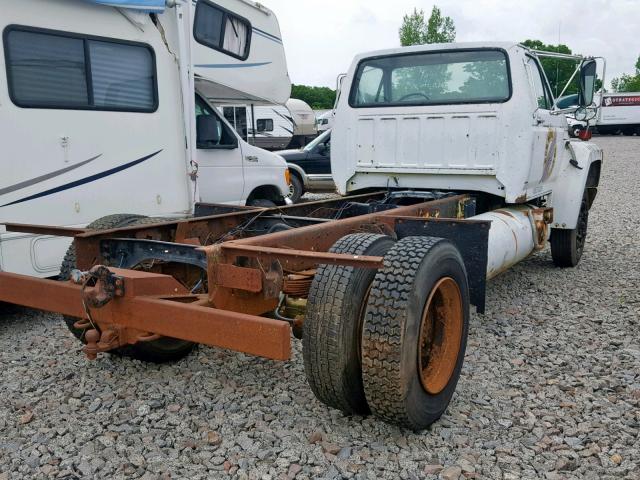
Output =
[{"x1": 59, "y1": 213, "x2": 195, "y2": 363}]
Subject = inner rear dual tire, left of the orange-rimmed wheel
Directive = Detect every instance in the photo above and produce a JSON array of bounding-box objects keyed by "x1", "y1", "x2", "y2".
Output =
[{"x1": 302, "y1": 233, "x2": 394, "y2": 415}]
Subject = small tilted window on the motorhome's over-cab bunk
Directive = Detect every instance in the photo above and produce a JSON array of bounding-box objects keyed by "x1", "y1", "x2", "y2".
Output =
[{"x1": 193, "y1": 0, "x2": 251, "y2": 60}]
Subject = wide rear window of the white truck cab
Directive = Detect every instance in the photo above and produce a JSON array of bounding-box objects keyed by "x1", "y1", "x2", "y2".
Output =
[{"x1": 349, "y1": 49, "x2": 511, "y2": 107}]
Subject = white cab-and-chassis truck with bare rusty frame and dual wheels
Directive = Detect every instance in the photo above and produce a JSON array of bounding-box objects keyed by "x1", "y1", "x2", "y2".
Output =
[{"x1": 0, "y1": 43, "x2": 603, "y2": 430}]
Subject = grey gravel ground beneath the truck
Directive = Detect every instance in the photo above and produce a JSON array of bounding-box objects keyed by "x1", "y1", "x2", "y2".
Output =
[{"x1": 0, "y1": 137, "x2": 640, "y2": 480}]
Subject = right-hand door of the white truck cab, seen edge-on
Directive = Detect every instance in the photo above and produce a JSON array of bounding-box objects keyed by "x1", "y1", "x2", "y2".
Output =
[{"x1": 526, "y1": 56, "x2": 568, "y2": 191}]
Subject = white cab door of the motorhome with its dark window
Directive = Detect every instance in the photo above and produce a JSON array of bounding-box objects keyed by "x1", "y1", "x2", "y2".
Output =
[{"x1": 195, "y1": 96, "x2": 244, "y2": 205}]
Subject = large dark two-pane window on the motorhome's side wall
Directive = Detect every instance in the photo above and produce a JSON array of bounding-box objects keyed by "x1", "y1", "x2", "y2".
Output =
[{"x1": 5, "y1": 27, "x2": 157, "y2": 112}]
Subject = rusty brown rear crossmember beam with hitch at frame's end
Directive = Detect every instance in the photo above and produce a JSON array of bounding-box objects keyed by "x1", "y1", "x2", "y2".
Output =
[{"x1": 0, "y1": 269, "x2": 291, "y2": 360}]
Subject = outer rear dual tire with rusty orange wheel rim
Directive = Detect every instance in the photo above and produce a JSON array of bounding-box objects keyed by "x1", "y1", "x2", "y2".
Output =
[{"x1": 362, "y1": 237, "x2": 469, "y2": 431}]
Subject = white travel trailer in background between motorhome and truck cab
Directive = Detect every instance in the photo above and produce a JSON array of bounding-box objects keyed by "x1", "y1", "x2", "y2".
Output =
[{"x1": 222, "y1": 98, "x2": 318, "y2": 150}]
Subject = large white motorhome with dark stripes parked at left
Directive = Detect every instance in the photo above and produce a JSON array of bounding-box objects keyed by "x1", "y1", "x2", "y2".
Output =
[{"x1": 0, "y1": 0, "x2": 290, "y2": 277}]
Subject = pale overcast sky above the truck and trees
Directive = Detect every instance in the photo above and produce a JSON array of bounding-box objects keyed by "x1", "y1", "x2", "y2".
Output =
[{"x1": 261, "y1": 0, "x2": 640, "y2": 87}]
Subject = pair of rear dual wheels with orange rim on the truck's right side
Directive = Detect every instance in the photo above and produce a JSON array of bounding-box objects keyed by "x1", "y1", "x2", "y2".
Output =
[{"x1": 303, "y1": 234, "x2": 469, "y2": 430}]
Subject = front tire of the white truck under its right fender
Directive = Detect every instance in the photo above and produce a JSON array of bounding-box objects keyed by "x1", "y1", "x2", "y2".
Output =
[{"x1": 549, "y1": 192, "x2": 589, "y2": 268}]
